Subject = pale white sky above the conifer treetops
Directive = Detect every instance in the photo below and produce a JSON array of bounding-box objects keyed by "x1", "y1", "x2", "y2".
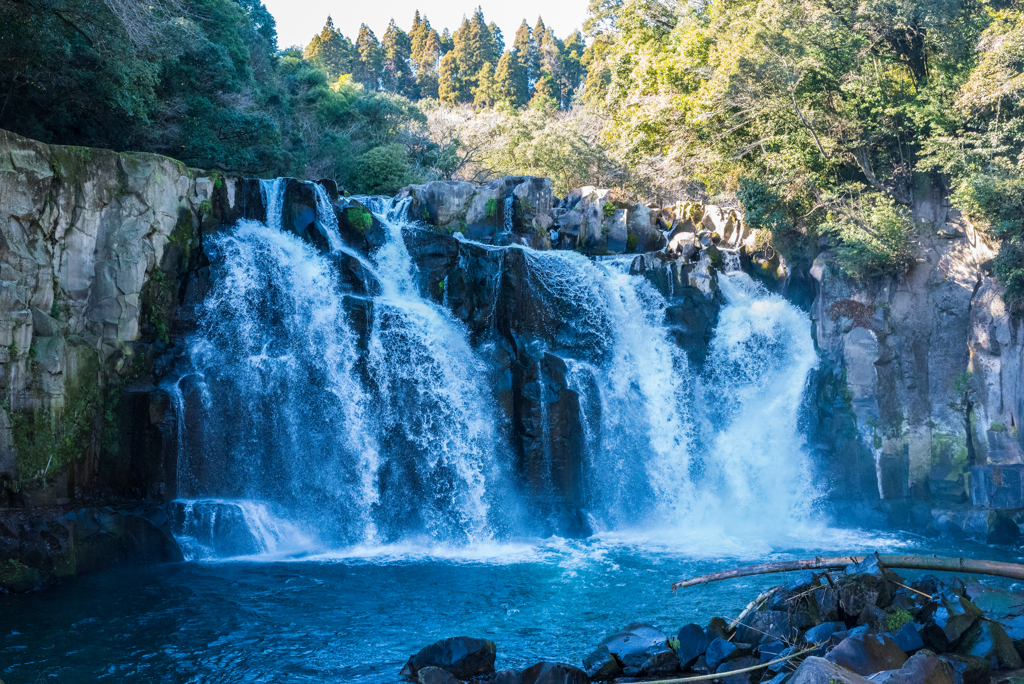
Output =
[{"x1": 263, "y1": 0, "x2": 588, "y2": 48}]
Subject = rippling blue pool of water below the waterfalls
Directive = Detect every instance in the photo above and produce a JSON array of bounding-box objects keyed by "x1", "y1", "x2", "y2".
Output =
[{"x1": 0, "y1": 530, "x2": 1017, "y2": 684}]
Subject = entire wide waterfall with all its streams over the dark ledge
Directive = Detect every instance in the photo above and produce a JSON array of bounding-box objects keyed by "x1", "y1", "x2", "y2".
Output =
[{"x1": 169, "y1": 179, "x2": 818, "y2": 558}]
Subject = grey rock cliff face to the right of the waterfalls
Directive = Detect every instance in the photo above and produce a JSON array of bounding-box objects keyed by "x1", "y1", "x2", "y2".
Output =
[{"x1": 810, "y1": 178, "x2": 1024, "y2": 541}]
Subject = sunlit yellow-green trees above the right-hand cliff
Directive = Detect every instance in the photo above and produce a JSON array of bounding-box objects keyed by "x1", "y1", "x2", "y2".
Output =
[{"x1": 588, "y1": 0, "x2": 1011, "y2": 275}]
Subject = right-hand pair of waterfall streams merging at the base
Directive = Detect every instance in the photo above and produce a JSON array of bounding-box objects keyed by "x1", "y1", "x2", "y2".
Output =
[{"x1": 513, "y1": 248, "x2": 819, "y2": 535}]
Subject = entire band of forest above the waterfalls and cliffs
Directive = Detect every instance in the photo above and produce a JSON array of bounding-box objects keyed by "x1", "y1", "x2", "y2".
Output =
[{"x1": 6, "y1": 0, "x2": 1024, "y2": 294}]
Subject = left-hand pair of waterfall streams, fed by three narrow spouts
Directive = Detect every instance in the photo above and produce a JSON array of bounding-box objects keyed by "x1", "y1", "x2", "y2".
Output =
[{"x1": 170, "y1": 179, "x2": 516, "y2": 557}]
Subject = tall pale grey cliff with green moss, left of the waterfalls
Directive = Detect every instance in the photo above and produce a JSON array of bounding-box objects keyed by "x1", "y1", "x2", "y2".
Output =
[{"x1": 0, "y1": 131, "x2": 263, "y2": 590}]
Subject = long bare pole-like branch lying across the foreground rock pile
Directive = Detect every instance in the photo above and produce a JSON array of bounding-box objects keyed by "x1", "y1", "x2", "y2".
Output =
[{"x1": 672, "y1": 555, "x2": 1024, "y2": 591}]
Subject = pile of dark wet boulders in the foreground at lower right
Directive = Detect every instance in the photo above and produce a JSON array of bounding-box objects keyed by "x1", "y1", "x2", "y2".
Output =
[{"x1": 400, "y1": 555, "x2": 1024, "y2": 684}]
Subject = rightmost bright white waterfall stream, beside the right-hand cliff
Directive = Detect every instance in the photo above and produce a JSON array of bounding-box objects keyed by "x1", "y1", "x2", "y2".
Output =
[{"x1": 701, "y1": 272, "x2": 819, "y2": 529}]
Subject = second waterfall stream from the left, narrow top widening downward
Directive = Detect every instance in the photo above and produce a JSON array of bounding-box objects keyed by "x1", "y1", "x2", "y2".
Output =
[{"x1": 368, "y1": 194, "x2": 500, "y2": 542}]
